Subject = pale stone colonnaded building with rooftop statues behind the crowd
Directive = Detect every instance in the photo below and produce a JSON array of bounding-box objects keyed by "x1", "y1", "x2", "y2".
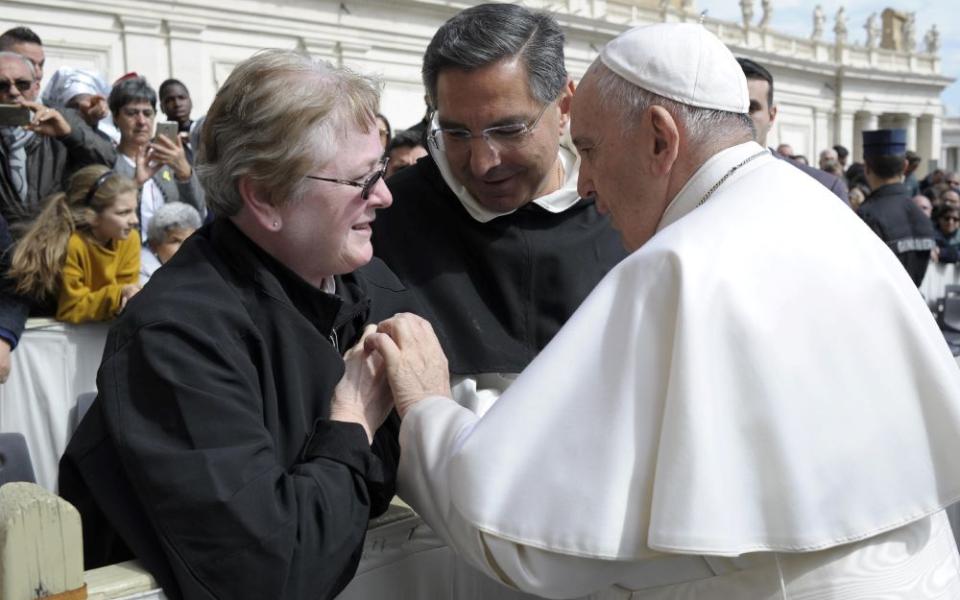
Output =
[{"x1": 0, "y1": 0, "x2": 960, "y2": 175}]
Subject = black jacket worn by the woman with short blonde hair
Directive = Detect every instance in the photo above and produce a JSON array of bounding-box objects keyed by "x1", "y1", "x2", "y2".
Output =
[{"x1": 60, "y1": 220, "x2": 413, "y2": 600}]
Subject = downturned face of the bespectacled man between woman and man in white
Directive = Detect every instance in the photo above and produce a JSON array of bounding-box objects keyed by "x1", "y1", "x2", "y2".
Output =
[{"x1": 437, "y1": 58, "x2": 572, "y2": 212}]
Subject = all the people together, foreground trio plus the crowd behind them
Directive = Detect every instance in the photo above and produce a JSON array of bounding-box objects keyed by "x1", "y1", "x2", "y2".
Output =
[{"x1": 0, "y1": 8, "x2": 960, "y2": 600}]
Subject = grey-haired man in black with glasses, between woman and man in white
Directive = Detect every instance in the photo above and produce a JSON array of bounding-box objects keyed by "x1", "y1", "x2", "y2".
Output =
[{"x1": 374, "y1": 4, "x2": 624, "y2": 413}]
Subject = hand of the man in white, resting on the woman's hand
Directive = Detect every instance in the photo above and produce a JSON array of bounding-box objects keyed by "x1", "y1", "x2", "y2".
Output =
[{"x1": 366, "y1": 313, "x2": 451, "y2": 418}]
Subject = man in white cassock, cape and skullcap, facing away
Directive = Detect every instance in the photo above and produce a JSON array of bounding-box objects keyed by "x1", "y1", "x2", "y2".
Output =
[{"x1": 367, "y1": 24, "x2": 960, "y2": 600}]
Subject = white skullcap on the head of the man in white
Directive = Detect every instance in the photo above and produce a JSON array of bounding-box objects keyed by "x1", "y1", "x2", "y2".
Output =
[{"x1": 600, "y1": 23, "x2": 750, "y2": 114}]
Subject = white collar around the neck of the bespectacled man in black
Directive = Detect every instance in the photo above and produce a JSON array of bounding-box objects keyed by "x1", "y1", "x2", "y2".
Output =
[{"x1": 427, "y1": 115, "x2": 580, "y2": 223}]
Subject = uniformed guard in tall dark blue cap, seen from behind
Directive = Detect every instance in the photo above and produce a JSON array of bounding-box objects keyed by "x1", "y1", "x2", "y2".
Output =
[{"x1": 857, "y1": 129, "x2": 936, "y2": 286}]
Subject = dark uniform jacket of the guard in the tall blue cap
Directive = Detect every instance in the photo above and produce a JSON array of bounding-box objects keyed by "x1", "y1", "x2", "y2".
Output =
[{"x1": 857, "y1": 183, "x2": 936, "y2": 286}]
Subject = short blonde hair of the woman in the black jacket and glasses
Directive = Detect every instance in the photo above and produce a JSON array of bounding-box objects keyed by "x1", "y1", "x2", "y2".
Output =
[{"x1": 196, "y1": 50, "x2": 380, "y2": 217}]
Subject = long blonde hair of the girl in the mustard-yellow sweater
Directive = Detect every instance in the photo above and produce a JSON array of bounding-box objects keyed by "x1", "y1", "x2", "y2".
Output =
[{"x1": 9, "y1": 165, "x2": 137, "y2": 300}]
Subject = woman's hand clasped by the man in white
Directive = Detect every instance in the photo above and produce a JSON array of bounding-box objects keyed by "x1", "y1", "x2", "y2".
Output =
[{"x1": 330, "y1": 325, "x2": 393, "y2": 443}]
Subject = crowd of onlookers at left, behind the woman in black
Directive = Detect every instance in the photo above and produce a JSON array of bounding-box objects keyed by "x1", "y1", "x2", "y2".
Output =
[{"x1": 0, "y1": 27, "x2": 427, "y2": 380}]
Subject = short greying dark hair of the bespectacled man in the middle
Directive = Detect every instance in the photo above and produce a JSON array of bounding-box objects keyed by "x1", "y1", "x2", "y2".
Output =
[{"x1": 422, "y1": 4, "x2": 567, "y2": 108}]
